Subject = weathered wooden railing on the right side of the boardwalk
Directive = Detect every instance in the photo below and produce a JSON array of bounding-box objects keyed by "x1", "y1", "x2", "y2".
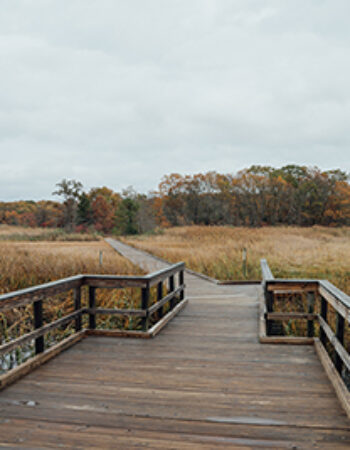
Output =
[{"x1": 260, "y1": 260, "x2": 350, "y2": 414}]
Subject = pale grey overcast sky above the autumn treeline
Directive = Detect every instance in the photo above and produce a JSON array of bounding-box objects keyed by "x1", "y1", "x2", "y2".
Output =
[{"x1": 0, "y1": 0, "x2": 350, "y2": 200}]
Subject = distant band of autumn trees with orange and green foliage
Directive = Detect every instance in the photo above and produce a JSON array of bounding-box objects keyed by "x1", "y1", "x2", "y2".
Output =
[{"x1": 0, "y1": 165, "x2": 350, "y2": 234}]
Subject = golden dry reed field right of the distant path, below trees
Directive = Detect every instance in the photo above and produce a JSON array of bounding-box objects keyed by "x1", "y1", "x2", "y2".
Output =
[{"x1": 125, "y1": 226, "x2": 350, "y2": 294}]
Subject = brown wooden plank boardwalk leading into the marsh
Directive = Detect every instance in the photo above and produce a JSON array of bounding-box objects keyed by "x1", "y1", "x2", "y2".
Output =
[{"x1": 0, "y1": 239, "x2": 350, "y2": 449}]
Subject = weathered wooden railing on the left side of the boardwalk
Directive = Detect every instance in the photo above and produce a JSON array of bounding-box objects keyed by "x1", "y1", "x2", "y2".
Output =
[{"x1": 0, "y1": 263, "x2": 187, "y2": 388}]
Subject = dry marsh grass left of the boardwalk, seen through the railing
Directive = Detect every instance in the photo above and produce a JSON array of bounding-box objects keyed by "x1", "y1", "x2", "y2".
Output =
[{"x1": 0, "y1": 229, "x2": 142, "y2": 373}]
